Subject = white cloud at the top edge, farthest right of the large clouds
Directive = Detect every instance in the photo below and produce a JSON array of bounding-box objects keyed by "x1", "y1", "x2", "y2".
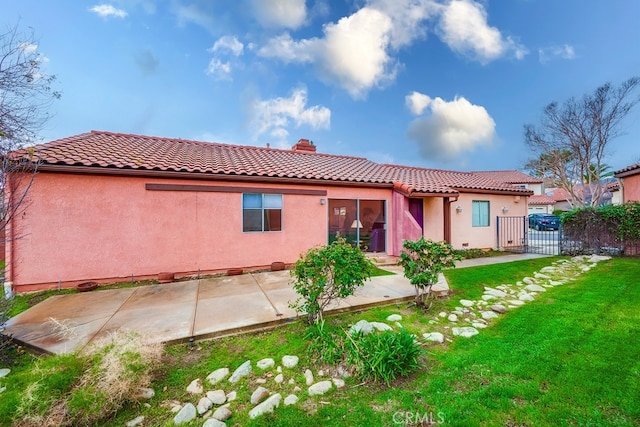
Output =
[{"x1": 438, "y1": 0, "x2": 528, "y2": 64}]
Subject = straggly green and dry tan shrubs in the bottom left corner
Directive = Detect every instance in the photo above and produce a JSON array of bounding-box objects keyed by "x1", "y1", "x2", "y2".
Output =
[{"x1": 8, "y1": 332, "x2": 163, "y2": 426}]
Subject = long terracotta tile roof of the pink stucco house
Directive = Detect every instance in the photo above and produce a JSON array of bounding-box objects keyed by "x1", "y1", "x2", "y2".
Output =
[{"x1": 11, "y1": 131, "x2": 531, "y2": 195}]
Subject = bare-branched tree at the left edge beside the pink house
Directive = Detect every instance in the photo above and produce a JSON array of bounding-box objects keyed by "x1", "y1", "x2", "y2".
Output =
[{"x1": 0, "y1": 24, "x2": 60, "y2": 234}]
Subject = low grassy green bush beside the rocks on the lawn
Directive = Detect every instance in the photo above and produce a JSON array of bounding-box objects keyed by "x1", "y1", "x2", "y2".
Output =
[{"x1": 347, "y1": 328, "x2": 424, "y2": 385}]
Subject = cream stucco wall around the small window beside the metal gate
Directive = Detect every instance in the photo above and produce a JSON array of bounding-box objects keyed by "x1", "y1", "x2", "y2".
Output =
[{"x1": 451, "y1": 193, "x2": 527, "y2": 249}]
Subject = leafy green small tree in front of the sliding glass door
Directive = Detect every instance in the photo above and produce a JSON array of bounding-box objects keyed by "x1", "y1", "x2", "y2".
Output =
[{"x1": 290, "y1": 238, "x2": 374, "y2": 323}]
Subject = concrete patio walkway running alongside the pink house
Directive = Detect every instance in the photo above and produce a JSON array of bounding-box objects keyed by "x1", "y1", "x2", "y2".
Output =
[{"x1": 5, "y1": 254, "x2": 540, "y2": 354}]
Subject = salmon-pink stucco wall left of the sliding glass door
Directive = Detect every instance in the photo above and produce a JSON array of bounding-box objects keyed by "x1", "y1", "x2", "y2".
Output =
[{"x1": 10, "y1": 173, "x2": 391, "y2": 291}]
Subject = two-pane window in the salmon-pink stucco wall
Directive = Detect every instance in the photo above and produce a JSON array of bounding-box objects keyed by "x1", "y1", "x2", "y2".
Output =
[{"x1": 242, "y1": 193, "x2": 282, "y2": 232}]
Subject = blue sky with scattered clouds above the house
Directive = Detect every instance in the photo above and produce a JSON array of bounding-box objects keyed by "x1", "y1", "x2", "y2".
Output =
[{"x1": 5, "y1": 0, "x2": 640, "y2": 170}]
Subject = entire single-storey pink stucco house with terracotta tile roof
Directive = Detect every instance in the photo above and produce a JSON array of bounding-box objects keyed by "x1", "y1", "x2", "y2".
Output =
[{"x1": 6, "y1": 131, "x2": 532, "y2": 292}]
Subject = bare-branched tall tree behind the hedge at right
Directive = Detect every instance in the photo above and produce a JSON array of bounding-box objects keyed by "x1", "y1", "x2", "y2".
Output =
[{"x1": 524, "y1": 77, "x2": 640, "y2": 207}]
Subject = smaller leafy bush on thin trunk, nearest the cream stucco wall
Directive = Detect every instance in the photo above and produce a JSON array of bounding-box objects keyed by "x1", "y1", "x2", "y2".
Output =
[{"x1": 398, "y1": 237, "x2": 462, "y2": 308}]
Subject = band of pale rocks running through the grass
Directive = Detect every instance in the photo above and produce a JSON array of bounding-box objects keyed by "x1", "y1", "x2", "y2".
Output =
[{"x1": 116, "y1": 255, "x2": 610, "y2": 427}]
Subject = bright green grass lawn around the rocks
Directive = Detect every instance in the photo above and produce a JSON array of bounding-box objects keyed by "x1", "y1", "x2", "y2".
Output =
[{"x1": 0, "y1": 258, "x2": 640, "y2": 426}]
